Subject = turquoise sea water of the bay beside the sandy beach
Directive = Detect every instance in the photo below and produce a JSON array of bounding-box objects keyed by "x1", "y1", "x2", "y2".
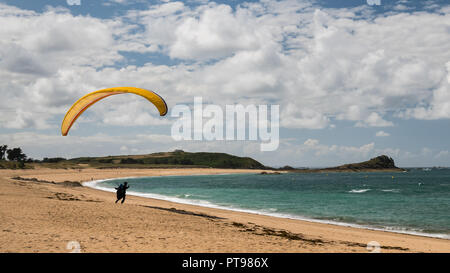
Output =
[{"x1": 93, "y1": 169, "x2": 450, "y2": 239}]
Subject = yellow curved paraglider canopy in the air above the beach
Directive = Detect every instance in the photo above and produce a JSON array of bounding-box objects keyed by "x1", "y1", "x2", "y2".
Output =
[{"x1": 61, "y1": 87, "x2": 167, "y2": 136}]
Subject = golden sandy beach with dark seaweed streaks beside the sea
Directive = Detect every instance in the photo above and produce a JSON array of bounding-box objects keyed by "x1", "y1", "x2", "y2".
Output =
[{"x1": 0, "y1": 168, "x2": 450, "y2": 253}]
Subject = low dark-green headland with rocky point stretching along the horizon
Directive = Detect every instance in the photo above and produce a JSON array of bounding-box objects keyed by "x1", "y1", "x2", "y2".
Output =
[{"x1": 0, "y1": 150, "x2": 404, "y2": 173}]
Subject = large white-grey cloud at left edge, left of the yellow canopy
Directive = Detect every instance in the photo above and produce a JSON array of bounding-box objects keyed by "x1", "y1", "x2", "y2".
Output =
[{"x1": 0, "y1": 4, "x2": 133, "y2": 129}]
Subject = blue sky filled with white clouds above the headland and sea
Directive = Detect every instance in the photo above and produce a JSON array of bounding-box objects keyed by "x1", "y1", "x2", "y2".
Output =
[{"x1": 0, "y1": 0, "x2": 450, "y2": 167}]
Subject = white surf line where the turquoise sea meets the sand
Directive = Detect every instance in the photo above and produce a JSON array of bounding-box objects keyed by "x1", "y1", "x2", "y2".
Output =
[{"x1": 82, "y1": 173, "x2": 450, "y2": 238}]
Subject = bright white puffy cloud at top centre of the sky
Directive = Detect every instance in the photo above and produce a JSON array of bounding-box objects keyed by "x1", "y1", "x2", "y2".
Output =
[{"x1": 169, "y1": 5, "x2": 262, "y2": 60}]
